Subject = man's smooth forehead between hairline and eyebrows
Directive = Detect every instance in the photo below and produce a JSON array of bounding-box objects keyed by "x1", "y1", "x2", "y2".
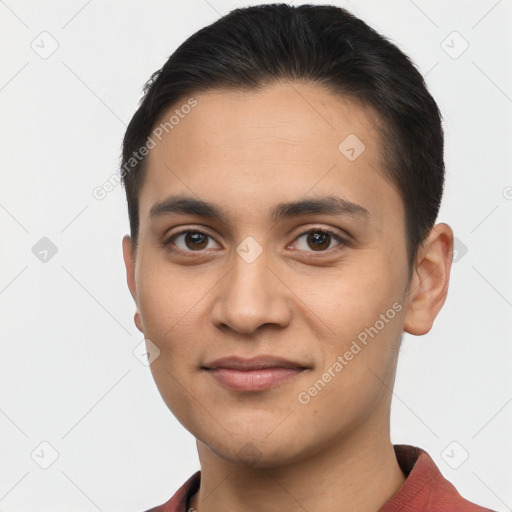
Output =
[{"x1": 139, "y1": 83, "x2": 400, "y2": 230}]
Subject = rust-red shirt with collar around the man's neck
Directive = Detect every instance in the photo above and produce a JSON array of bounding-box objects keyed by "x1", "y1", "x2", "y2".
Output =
[{"x1": 142, "y1": 444, "x2": 493, "y2": 512}]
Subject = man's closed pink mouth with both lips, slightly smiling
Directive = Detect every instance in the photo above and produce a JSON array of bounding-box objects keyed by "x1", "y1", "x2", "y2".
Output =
[{"x1": 203, "y1": 356, "x2": 310, "y2": 392}]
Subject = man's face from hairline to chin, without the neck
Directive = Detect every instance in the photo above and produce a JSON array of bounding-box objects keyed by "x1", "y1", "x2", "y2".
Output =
[{"x1": 124, "y1": 83, "x2": 416, "y2": 467}]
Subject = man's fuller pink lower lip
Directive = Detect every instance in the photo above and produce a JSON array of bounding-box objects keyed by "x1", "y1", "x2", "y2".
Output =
[{"x1": 208, "y1": 368, "x2": 302, "y2": 391}]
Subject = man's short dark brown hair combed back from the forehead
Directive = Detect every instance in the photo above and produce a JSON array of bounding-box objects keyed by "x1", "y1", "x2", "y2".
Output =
[{"x1": 121, "y1": 4, "x2": 444, "y2": 279}]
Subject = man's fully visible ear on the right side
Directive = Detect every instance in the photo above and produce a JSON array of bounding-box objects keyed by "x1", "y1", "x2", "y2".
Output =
[{"x1": 404, "y1": 223, "x2": 453, "y2": 336}]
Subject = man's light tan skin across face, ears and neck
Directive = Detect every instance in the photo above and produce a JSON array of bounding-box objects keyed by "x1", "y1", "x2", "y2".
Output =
[{"x1": 123, "y1": 82, "x2": 453, "y2": 512}]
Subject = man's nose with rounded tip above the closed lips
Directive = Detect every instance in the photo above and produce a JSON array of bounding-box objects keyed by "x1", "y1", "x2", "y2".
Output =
[{"x1": 212, "y1": 251, "x2": 292, "y2": 334}]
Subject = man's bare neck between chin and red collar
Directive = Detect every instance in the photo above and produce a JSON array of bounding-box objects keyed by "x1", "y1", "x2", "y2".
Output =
[{"x1": 190, "y1": 431, "x2": 405, "y2": 512}]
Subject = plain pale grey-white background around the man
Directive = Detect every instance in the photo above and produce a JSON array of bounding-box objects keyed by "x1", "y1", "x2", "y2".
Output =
[{"x1": 0, "y1": 0, "x2": 512, "y2": 512}]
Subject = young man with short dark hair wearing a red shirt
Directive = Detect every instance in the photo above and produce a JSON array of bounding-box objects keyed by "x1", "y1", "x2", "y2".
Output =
[{"x1": 121, "y1": 4, "x2": 496, "y2": 512}]
